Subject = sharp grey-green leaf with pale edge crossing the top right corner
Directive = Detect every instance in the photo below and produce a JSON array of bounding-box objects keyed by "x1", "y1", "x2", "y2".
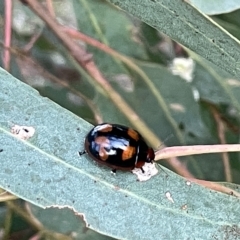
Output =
[{"x1": 110, "y1": 0, "x2": 240, "y2": 76}]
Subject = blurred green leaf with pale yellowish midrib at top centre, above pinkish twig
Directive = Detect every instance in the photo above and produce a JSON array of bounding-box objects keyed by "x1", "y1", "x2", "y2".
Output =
[{"x1": 72, "y1": 0, "x2": 146, "y2": 59}]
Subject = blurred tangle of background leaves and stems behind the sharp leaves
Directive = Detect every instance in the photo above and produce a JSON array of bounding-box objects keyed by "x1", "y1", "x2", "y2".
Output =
[{"x1": 0, "y1": 0, "x2": 240, "y2": 239}]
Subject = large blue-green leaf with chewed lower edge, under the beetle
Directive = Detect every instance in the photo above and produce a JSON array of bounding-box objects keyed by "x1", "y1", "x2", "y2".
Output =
[{"x1": 0, "y1": 70, "x2": 240, "y2": 239}]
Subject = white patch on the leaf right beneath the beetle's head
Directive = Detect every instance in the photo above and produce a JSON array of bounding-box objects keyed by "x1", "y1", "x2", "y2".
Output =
[{"x1": 132, "y1": 163, "x2": 158, "y2": 182}]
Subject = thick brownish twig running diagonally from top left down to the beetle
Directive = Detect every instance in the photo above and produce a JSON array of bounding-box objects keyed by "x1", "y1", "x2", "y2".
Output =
[{"x1": 23, "y1": 0, "x2": 160, "y2": 148}]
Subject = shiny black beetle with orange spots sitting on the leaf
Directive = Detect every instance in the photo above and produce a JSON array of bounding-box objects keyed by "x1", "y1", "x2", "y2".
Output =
[{"x1": 79, "y1": 123, "x2": 155, "y2": 172}]
